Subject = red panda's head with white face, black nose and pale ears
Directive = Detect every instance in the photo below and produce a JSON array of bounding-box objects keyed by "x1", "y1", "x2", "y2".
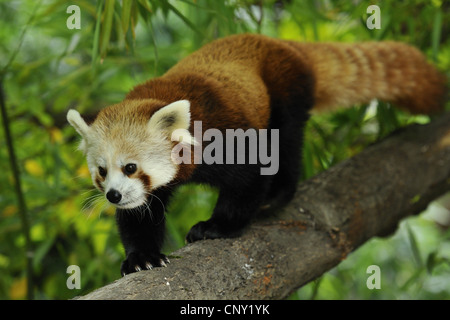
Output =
[{"x1": 67, "y1": 99, "x2": 195, "y2": 209}]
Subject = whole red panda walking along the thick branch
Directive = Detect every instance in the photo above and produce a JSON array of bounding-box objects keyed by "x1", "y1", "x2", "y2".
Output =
[{"x1": 67, "y1": 34, "x2": 446, "y2": 275}]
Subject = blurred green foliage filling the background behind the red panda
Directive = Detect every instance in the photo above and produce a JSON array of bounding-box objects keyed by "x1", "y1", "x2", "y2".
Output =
[{"x1": 0, "y1": 0, "x2": 450, "y2": 299}]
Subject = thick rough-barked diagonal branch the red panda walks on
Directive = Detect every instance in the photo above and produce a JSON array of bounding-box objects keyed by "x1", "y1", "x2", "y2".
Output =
[{"x1": 78, "y1": 114, "x2": 450, "y2": 299}]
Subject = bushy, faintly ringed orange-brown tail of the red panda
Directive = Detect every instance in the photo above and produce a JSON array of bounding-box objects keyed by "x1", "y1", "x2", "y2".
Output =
[{"x1": 289, "y1": 41, "x2": 447, "y2": 114}]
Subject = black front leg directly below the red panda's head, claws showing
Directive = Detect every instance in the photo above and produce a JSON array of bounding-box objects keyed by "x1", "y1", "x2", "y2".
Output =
[{"x1": 116, "y1": 192, "x2": 170, "y2": 275}]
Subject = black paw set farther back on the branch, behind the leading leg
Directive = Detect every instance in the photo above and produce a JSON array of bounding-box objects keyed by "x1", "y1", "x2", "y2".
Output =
[{"x1": 186, "y1": 220, "x2": 241, "y2": 243}]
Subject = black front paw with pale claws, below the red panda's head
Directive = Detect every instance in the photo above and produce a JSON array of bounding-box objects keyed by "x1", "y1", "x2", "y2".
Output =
[{"x1": 120, "y1": 252, "x2": 170, "y2": 276}]
